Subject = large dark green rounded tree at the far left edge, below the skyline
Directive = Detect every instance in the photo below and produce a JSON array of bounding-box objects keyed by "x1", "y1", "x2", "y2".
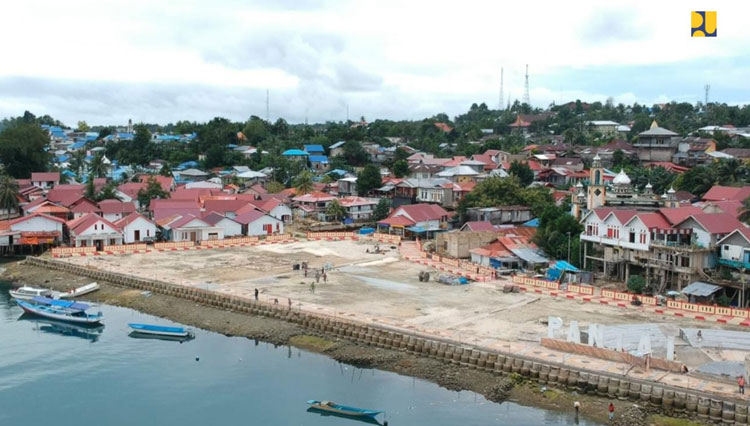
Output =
[{"x1": 0, "y1": 123, "x2": 50, "y2": 178}]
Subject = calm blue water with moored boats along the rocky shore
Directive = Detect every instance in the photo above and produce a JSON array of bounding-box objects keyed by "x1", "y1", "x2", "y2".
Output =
[{"x1": 0, "y1": 283, "x2": 593, "y2": 426}]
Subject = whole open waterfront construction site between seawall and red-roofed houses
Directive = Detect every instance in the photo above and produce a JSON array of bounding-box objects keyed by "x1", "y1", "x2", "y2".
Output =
[{"x1": 55, "y1": 238, "x2": 750, "y2": 380}]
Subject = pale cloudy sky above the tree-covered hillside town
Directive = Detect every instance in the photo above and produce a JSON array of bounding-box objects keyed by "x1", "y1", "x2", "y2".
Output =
[{"x1": 0, "y1": 0, "x2": 750, "y2": 126}]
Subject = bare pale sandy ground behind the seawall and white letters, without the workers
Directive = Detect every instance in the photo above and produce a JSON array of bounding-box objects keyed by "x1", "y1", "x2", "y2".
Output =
[{"x1": 57, "y1": 241, "x2": 736, "y2": 361}]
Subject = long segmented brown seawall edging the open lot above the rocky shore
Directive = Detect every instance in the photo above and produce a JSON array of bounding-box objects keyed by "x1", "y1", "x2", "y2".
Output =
[{"x1": 25, "y1": 257, "x2": 748, "y2": 425}]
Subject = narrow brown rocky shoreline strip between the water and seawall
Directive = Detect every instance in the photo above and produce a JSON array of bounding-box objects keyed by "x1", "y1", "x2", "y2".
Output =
[{"x1": 0, "y1": 261, "x2": 704, "y2": 424}]
